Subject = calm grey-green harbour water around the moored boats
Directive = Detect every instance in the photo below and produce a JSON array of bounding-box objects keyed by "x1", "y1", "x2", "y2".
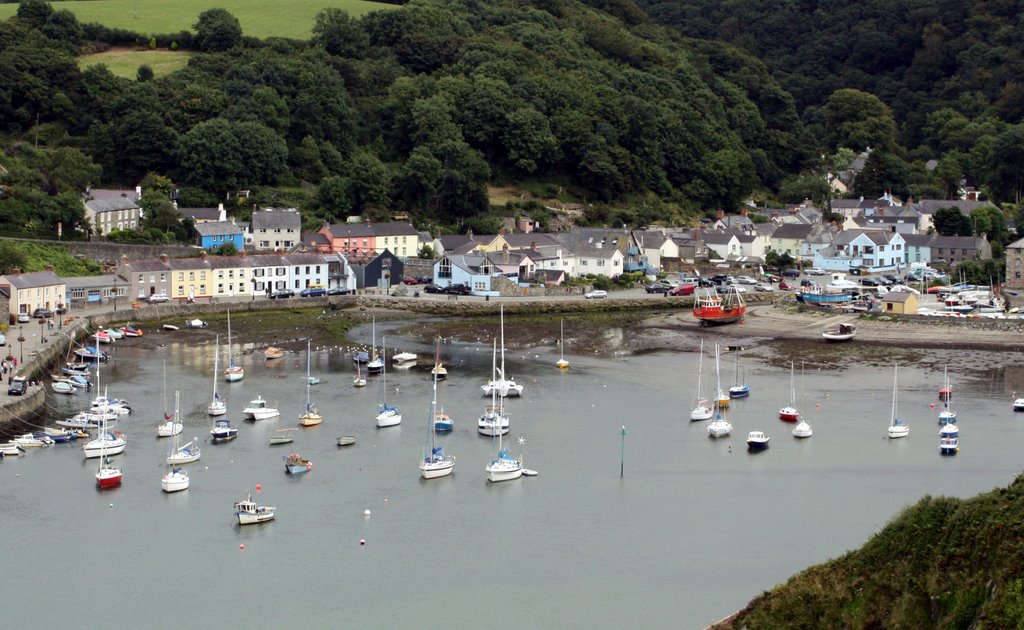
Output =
[{"x1": 0, "y1": 331, "x2": 1024, "y2": 629}]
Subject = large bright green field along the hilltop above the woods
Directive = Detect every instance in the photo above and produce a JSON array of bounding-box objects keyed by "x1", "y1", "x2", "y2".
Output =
[{"x1": 0, "y1": 0, "x2": 396, "y2": 39}]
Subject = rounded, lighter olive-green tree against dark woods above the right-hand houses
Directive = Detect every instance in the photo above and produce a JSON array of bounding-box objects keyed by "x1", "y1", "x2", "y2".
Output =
[{"x1": 821, "y1": 89, "x2": 896, "y2": 152}]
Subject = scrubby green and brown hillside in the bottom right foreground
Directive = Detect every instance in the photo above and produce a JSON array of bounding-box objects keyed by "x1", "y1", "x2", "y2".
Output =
[{"x1": 715, "y1": 476, "x2": 1024, "y2": 630}]
